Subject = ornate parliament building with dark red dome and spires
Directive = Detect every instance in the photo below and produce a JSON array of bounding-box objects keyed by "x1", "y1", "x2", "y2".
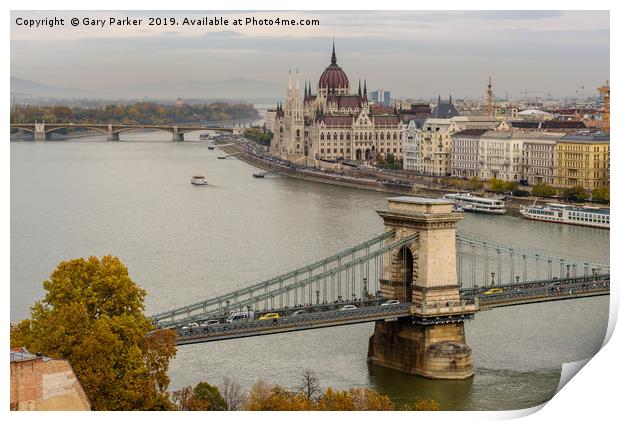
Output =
[{"x1": 270, "y1": 46, "x2": 404, "y2": 165}]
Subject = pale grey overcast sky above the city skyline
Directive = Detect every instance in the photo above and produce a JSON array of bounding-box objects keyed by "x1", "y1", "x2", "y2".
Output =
[{"x1": 11, "y1": 11, "x2": 610, "y2": 98}]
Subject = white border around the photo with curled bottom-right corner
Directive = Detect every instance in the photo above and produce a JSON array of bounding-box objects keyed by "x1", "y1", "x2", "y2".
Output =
[{"x1": 0, "y1": 0, "x2": 620, "y2": 420}]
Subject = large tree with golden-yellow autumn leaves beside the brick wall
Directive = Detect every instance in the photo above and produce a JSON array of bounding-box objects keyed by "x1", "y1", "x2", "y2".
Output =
[{"x1": 11, "y1": 256, "x2": 176, "y2": 410}]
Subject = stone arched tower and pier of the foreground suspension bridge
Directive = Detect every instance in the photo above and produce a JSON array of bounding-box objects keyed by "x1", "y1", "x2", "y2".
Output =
[{"x1": 368, "y1": 196, "x2": 476, "y2": 379}]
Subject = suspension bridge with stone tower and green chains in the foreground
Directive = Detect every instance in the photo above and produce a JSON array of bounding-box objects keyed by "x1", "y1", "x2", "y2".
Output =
[{"x1": 151, "y1": 197, "x2": 610, "y2": 378}]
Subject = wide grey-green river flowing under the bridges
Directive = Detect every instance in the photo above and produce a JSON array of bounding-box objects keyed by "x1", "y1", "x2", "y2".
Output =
[{"x1": 11, "y1": 132, "x2": 609, "y2": 410}]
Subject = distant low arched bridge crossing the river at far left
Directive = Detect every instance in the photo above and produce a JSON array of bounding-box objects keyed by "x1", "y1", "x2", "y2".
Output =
[{"x1": 11, "y1": 122, "x2": 237, "y2": 141}]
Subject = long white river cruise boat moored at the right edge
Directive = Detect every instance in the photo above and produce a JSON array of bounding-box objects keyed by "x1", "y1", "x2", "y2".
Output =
[{"x1": 519, "y1": 203, "x2": 609, "y2": 229}]
